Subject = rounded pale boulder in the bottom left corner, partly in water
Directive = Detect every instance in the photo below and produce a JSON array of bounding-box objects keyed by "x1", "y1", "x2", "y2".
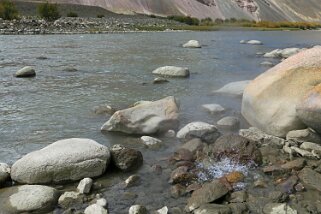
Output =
[{"x1": 0, "y1": 185, "x2": 59, "y2": 213}]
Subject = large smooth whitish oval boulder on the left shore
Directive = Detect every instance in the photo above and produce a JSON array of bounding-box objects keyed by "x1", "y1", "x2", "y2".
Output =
[{"x1": 11, "y1": 138, "x2": 110, "y2": 184}]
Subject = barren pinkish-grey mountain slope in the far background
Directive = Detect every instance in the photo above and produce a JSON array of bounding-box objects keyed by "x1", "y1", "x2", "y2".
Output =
[{"x1": 15, "y1": 0, "x2": 321, "y2": 22}]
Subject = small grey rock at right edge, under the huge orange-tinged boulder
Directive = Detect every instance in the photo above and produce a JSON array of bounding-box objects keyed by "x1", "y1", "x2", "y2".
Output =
[{"x1": 286, "y1": 129, "x2": 321, "y2": 144}]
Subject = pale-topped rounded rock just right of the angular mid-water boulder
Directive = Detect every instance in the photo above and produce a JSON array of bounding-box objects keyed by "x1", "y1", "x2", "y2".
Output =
[{"x1": 176, "y1": 122, "x2": 221, "y2": 143}]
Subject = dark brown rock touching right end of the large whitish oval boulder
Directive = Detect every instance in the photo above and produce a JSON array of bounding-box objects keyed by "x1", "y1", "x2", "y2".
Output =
[{"x1": 110, "y1": 144, "x2": 143, "y2": 172}]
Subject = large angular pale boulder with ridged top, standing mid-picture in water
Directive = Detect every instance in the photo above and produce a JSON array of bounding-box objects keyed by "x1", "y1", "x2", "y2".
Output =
[{"x1": 101, "y1": 97, "x2": 179, "y2": 135}]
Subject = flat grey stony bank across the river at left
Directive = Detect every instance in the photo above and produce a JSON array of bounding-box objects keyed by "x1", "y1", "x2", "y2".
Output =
[{"x1": 0, "y1": 16, "x2": 183, "y2": 35}]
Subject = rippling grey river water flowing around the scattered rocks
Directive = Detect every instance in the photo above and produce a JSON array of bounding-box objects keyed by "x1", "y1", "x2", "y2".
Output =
[{"x1": 0, "y1": 31, "x2": 321, "y2": 213}]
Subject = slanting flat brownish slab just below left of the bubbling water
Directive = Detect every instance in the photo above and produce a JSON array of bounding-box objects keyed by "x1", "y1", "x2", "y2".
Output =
[{"x1": 186, "y1": 180, "x2": 229, "y2": 212}]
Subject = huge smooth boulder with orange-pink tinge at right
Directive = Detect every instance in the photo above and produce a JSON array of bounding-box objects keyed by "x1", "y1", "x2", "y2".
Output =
[{"x1": 242, "y1": 47, "x2": 321, "y2": 137}]
